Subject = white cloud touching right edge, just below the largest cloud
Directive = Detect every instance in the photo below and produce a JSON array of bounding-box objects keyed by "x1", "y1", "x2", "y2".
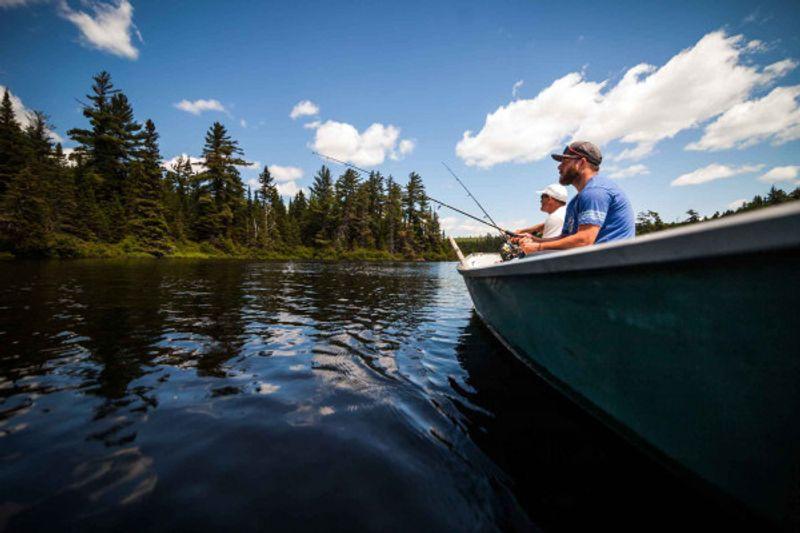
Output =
[{"x1": 686, "y1": 85, "x2": 800, "y2": 150}]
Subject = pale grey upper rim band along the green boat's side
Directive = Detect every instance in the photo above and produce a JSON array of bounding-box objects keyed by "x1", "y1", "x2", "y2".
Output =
[{"x1": 458, "y1": 201, "x2": 800, "y2": 277}]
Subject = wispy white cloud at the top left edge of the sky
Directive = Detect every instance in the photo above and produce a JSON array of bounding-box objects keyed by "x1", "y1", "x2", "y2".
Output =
[{"x1": 59, "y1": 0, "x2": 141, "y2": 59}]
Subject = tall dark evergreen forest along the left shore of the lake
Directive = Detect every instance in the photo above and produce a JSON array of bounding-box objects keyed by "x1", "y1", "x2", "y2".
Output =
[{"x1": 0, "y1": 72, "x2": 449, "y2": 260}]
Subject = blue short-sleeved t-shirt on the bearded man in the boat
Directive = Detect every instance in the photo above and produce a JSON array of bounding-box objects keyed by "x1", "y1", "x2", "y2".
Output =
[{"x1": 561, "y1": 176, "x2": 636, "y2": 244}]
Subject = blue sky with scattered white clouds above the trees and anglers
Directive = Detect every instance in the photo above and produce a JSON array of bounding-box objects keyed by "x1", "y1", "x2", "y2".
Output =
[{"x1": 0, "y1": 0, "x2": 800, "y2": 235}]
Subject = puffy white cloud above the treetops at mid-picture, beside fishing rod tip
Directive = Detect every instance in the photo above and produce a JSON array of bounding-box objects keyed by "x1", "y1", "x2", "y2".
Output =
[{"x1": 313, "y1": 120, "x2": 414, "y2": 166}]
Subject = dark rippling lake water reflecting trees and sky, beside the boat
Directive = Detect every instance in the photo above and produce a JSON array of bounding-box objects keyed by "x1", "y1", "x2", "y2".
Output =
[{"x1": 0, "y1": 261, "x2": 760, "y2": 531}]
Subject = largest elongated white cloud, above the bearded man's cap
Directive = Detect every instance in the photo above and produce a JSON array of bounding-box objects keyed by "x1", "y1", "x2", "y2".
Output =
[{"x1": 456, "y1": 31, "x2": 793, "y2": 168}]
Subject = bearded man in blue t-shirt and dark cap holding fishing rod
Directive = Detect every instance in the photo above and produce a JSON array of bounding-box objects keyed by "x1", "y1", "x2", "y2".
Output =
[{"x1": 513, "y1": 141, "x2": 636, "y2": 254}]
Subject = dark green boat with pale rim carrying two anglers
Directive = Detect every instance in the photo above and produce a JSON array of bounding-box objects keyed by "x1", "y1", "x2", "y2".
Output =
[{"x1": 458, "y1": 202, "x2": 800, "y2": 528}]
